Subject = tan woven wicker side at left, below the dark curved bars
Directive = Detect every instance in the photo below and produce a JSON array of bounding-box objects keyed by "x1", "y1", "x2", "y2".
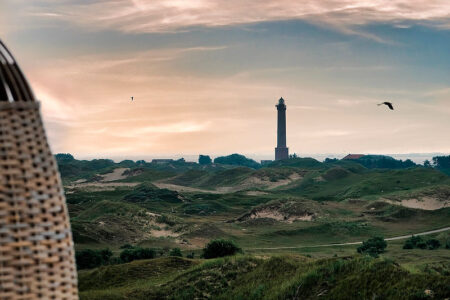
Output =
[{"x1": 0, "y1": 102, "x2": 78, "y2": 299}]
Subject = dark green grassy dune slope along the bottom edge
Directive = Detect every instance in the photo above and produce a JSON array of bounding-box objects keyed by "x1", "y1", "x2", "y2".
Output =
[{"x1": 79, "y1": 255, "x2": 450, "y2": 299}]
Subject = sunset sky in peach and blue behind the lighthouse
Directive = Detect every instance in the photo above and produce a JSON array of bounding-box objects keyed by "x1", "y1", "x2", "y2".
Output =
[{"x1": 0, "y1": 0, "x2": 450, "y2": 158}]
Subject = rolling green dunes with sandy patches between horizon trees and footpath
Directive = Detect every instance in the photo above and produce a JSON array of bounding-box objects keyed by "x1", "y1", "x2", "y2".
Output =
[{"x1": 59, "y1": 155, "x2": 450, "y2": 249}]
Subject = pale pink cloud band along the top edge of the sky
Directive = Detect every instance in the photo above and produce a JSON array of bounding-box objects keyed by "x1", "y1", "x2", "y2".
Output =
[{"x1": 22, "y1": 0, "x2": 450, "y2": 34}]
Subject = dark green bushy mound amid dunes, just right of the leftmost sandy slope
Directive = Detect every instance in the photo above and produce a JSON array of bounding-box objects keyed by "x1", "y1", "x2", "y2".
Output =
[{"x1": 123, "y1": 184, "x2": 181, "y2": 203}]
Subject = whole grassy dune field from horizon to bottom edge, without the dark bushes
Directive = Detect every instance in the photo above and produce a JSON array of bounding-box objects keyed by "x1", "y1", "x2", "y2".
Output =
[{"x1": 59, "y1": 159, "x2": 450, "y2": 299}]
